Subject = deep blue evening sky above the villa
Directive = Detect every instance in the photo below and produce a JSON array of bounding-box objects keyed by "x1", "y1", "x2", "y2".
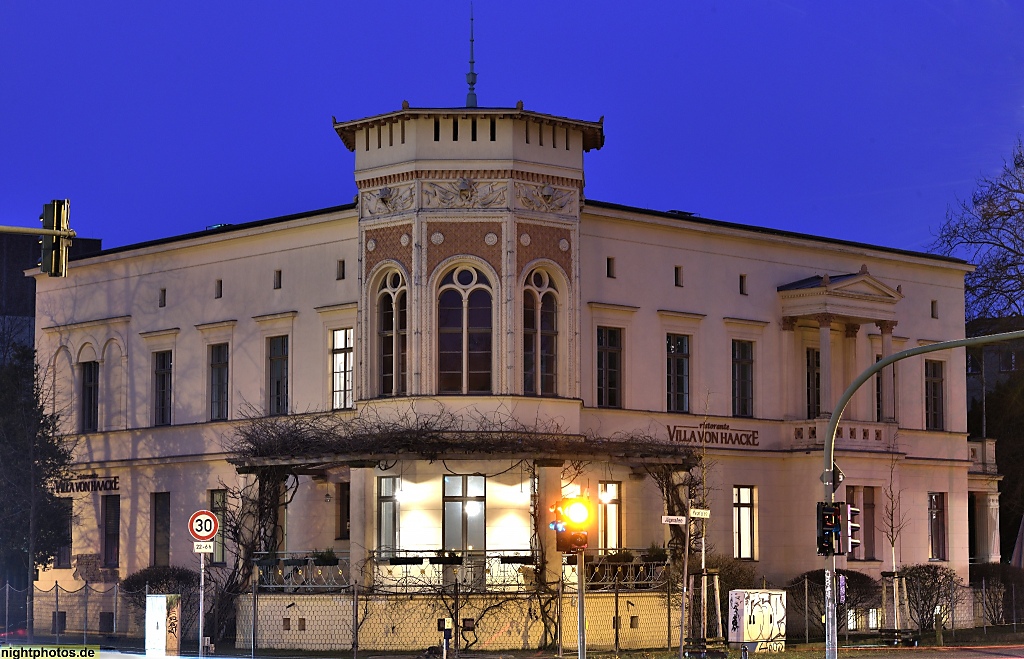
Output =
[{"x1": 0, "y1": 0, "x2": 1024, "y2": 250}]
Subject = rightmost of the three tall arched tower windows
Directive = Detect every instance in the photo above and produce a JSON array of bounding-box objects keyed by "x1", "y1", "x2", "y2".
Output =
[{"x1": 522, "y1": 269, "x2": 558, "y2": 396}]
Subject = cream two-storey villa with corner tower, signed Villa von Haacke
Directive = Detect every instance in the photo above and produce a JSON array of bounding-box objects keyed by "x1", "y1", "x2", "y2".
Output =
[{"x1": 35, "y1": 100, "x2": 999, "y2": 613}]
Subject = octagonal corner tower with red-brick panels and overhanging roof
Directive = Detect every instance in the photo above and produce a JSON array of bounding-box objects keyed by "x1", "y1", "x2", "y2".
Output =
[{"x1": 335, "y1": 103, "x2": 604, "y2": 396}]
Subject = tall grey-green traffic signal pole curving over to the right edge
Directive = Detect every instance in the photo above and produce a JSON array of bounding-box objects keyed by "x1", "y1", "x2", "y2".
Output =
[{"x1": 821, "y1": 330, "x2": 1024, "y2": 659}]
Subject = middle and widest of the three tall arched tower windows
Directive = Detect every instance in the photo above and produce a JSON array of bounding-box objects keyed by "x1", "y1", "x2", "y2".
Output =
[{"x1": 437, "y1": 266, "x2": 493, "y2": 394}]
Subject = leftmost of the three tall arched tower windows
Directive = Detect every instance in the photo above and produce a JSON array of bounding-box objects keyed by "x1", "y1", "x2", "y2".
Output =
[{"x1": 377, "y1": 271, "x2": 409, "y2": 396}]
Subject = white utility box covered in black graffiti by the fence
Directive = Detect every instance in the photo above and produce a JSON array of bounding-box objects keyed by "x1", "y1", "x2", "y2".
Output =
[{"x1": 728, "y1": 590, "x2": 785, "y2": 652}]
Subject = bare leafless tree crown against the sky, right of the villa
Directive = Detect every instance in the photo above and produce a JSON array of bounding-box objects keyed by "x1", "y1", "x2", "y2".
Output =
[{"x1": 932, "y1": 139, "x2": 1024, "y2": 318}]
